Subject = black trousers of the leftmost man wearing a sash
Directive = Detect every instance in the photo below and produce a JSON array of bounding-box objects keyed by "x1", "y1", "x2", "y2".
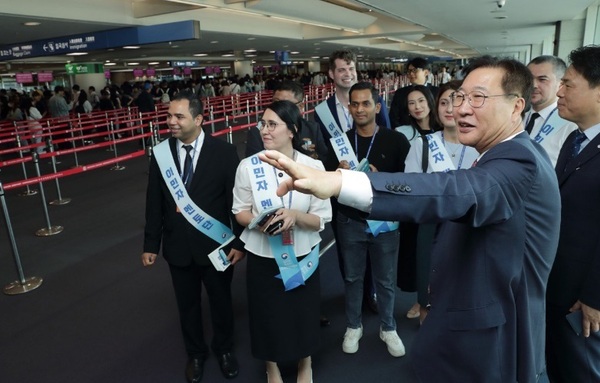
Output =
[{"x1": 169, "y1": 263, "x2": 234, "y2": 358}]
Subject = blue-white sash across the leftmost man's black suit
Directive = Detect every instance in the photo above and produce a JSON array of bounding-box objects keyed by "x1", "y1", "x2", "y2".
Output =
[{"x1": 153, "y1": 140, "x2": 235, "y2": 253}]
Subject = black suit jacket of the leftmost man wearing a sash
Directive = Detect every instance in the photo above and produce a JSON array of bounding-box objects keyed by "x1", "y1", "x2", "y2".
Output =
[{"x1": 144, "y1": 134, "x2": 244, "y2": 267}]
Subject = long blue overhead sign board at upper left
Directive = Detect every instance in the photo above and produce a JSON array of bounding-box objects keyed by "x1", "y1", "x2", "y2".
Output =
[{"x1": 0, "y1": 20, "x2": 200, "y2": 61}]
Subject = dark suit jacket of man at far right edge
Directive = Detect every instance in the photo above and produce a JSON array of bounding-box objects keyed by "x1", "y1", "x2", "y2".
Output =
[{"x1": 548, "y1": 132, "x2": 600, "y2": 314}]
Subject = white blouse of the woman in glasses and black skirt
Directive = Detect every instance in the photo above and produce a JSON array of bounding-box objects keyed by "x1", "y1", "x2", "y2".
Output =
[{"x1": 231, "y1": 153, "x2": 332, "y2": 258}]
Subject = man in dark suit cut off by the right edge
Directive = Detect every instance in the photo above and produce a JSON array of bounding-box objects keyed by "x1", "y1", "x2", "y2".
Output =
[{"x1": 546, "y1": 46, "x2": 600, "y2": 383}]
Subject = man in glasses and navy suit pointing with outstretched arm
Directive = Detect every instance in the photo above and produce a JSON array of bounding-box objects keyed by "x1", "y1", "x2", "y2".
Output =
[{"x1": 260, "y1": 57, "x2": 560, "y2": 383}]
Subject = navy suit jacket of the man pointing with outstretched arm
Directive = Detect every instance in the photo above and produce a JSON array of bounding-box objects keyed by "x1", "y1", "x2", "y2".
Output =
[{"x1": 367, "y1": 132, "x2": 560, "y2": 383}]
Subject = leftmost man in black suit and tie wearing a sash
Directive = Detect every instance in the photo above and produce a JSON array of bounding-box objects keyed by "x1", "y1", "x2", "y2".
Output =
[{"x1": 142, "y1": 91, "x2": 244, "y2": 383}]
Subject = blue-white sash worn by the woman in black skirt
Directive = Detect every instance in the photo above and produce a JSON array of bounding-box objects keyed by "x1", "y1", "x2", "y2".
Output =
[{"x1": 248, "y1": 155, "x2": 319, "y2": 291}]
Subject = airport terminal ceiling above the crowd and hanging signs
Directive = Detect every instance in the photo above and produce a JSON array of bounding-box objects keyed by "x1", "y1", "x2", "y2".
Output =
[{"x1": 0, "y1": 0, "x2": 597, "y2": 74}]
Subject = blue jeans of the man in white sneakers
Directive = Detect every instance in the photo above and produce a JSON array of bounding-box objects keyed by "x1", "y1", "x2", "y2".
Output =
[{"x1": 336, "y1": 212, "x2": 399, "y2": 331}]
